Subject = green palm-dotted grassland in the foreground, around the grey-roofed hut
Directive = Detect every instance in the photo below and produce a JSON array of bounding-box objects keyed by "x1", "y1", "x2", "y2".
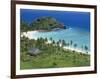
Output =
[{"x1": 20, "y1": 37, "x2": 90, "y2": 69}]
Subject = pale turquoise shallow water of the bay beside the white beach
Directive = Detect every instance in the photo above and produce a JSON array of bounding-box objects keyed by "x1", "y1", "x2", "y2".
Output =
[{"x1": 32, "y1": 28, "x2": 90, "y2": 51}]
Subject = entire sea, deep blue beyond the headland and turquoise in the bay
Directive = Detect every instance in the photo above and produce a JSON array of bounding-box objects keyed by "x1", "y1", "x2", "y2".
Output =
[{"x1": 20, "y1": 9, "x2": 90, "y2": 51}]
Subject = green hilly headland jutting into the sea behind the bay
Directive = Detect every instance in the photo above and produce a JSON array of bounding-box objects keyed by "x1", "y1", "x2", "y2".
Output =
[{"x1": 21, "y1": 16, "x2": 65, "y2": 32}]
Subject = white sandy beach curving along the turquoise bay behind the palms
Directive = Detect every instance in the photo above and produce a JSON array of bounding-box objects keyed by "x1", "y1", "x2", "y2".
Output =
[{"x1": 21, "y1": 30, "x2": 90, "y2": 54}]
